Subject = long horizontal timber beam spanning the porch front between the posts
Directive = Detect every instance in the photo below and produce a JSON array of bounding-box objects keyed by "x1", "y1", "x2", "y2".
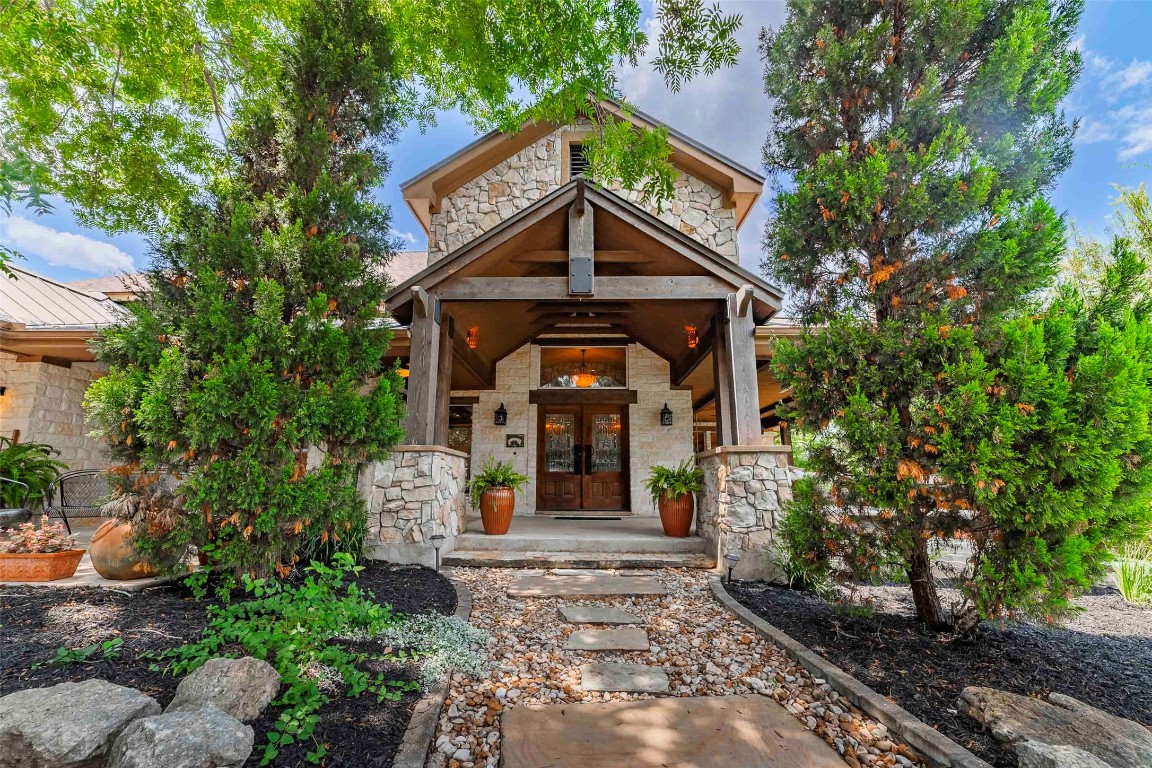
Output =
[{"x1": 429, "y1": 275, "x2": 734, "y2": 301}]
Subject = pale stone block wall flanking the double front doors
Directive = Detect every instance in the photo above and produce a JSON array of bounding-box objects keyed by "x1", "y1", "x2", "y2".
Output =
[{"x1": 453, "y1": 343, "x2": 692, "y2": 515}]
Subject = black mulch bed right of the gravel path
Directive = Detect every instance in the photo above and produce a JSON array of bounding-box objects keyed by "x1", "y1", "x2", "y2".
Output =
[{"x1": 728, "y1": 581, "x2": 1152, "y2": 768}]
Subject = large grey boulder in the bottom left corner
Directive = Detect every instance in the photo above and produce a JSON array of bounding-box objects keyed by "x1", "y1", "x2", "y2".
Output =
[{"x1": 0, "y1": 679, "x2": 160, "y2": 768}]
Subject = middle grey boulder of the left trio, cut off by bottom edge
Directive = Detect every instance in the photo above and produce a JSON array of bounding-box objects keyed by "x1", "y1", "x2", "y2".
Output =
[{"x1": 106, "y1": 704, "x2": 256, "y2": 768}]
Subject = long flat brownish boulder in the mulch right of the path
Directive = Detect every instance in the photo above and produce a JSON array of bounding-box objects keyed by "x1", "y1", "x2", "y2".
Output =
[{"x1": 957, "y1": 687, "x2": 1152, "y2": 768}]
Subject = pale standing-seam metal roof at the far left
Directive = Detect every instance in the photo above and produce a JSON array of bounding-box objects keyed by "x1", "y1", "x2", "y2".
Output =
[{"x1": 0, "y1": 264, "x2": 124, "y2": 330}]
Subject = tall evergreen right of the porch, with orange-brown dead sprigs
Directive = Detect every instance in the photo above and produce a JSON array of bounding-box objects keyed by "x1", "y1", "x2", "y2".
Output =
[{"x1": 761, "y1": 0, "x2": 1152, "y2": 632}]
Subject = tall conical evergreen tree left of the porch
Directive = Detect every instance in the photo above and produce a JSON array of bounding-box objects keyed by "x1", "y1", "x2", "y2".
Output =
[{"x1": 86, "y1": 0, "x2": 403, "y2": 576}]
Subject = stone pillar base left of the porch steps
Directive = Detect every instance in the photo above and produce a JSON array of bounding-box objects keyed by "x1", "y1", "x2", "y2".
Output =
[{"x1": 361, "y1": 446, "x2": 468, "y2": 565}]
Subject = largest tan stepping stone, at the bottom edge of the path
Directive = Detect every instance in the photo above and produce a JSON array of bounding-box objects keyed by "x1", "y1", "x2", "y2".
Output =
[{"x1": 500, "y1": 695, "x2": 844, "y2": 768}]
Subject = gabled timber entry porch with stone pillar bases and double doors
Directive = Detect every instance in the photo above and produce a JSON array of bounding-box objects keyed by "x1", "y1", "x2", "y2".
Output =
[{"x1": 365, "y1": 180, "x2": 789, "y2": 575}]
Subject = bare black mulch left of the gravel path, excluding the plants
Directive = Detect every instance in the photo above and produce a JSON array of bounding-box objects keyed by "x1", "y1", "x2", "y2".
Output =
[{"x1": 0, "y1": 563, "x2": 456, "y2": 768}]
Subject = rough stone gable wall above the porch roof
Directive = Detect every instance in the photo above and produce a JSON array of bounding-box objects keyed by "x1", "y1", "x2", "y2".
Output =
[{"x1": 429, "y1": 126, "x2": 740, "y2": 264}]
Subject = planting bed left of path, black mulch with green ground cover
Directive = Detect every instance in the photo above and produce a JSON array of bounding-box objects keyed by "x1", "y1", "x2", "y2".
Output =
[{"x1": 0, "y1": 563, "x2": 458, "y2": 766}]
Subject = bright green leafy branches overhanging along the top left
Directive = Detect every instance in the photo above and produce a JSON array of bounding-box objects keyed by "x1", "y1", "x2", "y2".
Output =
[{"x1": 0, "y1": 0, "x2": 740, "y2": 231}]
